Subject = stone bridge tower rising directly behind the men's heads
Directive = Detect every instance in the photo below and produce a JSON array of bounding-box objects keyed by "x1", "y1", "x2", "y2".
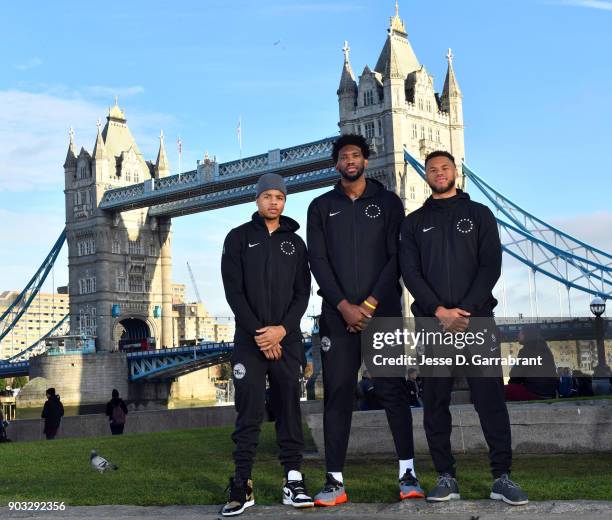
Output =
[{"x1": 337, "y1": 2, "x2": 465, "y2": 213}]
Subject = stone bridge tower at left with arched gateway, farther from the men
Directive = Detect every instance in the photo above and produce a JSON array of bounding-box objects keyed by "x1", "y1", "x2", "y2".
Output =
[{"x1": 64, "y1": 99, "x2": 172, "y2": 351}]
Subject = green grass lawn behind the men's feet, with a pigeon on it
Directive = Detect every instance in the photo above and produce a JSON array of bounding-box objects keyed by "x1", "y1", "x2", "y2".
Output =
[{"x1": 0, "y1": 423, "x2": 612, "y2": 505}]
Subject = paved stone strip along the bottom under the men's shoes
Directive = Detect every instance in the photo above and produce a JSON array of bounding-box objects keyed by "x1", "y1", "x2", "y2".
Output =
[{"x1": 0, "y1": 500, "x2": 612, "y2": 520}]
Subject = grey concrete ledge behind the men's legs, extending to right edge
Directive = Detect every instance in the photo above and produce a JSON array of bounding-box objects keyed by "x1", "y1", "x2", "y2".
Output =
[{"x1": 306, "y1": 400, "x2": 612, "y2": 455}]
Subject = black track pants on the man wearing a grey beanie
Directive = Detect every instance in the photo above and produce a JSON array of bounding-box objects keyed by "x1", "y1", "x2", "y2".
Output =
[{"x1": 232, "y1": 343, "x2": 304, "y2": 479}]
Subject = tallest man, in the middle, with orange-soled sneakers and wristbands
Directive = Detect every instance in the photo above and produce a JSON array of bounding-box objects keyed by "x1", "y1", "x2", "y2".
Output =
[{"x1": 307, "y1": 135, "x2": 424, "y2": 506}]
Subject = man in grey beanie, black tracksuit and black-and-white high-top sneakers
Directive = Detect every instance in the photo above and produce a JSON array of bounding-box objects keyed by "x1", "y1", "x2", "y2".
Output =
[{"x1": 221, "y1": 174, "x2": 314, "y2": 516}]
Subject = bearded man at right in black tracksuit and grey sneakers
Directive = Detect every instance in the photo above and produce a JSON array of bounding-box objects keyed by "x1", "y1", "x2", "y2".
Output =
[{"x1": 400, "y1": 151, "x2": 527, "y2": 505}]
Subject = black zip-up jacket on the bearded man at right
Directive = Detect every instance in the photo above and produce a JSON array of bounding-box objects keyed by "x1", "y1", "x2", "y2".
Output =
[{"x1": 399, "y1": 189, "x2": 502, "y2": 317}]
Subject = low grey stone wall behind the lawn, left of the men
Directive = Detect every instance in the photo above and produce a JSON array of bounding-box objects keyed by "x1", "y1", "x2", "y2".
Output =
[{"x1": 7, "y1": 401, "x2": 323, "y2": 442}]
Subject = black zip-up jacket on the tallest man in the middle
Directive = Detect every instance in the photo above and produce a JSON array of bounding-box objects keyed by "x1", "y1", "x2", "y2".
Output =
[{"x1": 307, "y1": 179, "x2": 404, "y2": 316}]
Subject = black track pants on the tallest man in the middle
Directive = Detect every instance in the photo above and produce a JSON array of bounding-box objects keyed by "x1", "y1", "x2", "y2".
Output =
[{"x1": 319, "y1": 309, "x2": 414, "y2": 471}]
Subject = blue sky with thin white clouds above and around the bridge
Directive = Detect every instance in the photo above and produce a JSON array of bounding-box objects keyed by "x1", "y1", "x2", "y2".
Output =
[{"x1": 0, "y1": 0, "x2": 612, "y2": 315}]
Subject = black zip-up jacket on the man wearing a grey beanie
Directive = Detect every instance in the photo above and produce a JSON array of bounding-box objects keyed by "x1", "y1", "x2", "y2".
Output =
[{"x1": 221, "y1": 212, "x2": 310, "y2": 345}]
